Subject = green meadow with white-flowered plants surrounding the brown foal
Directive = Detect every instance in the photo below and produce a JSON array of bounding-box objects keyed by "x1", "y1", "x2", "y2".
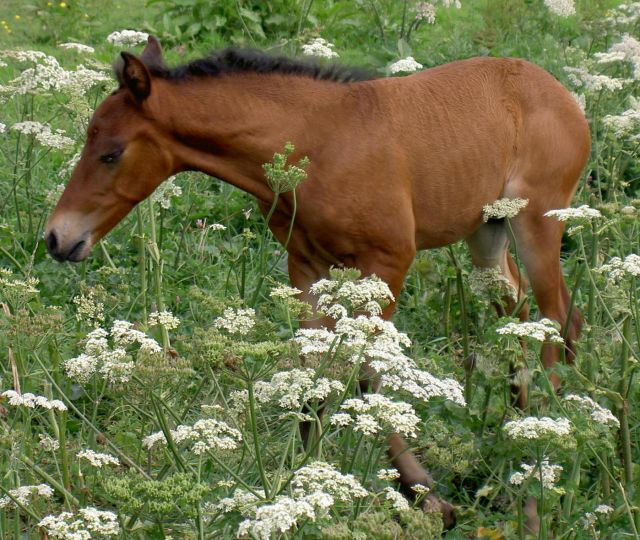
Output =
[{"x1": 0, "y1": 0, "x2": 640, "y2": 540}]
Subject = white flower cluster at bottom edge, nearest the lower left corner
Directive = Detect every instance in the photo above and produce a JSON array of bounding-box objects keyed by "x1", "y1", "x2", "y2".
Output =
[{"x1": 38, "y1": 506, "x2": 120, "y2": 540}]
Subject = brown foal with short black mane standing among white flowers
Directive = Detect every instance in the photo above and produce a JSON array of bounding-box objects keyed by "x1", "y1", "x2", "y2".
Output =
[{"x1": 45, "y1": 38, "x2": 590, "y2": 524}]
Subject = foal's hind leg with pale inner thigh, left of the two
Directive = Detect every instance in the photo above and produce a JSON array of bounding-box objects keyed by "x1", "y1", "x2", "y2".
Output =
[{"x1": 466, "y1": 220, "x2": 529, "y2": 409}]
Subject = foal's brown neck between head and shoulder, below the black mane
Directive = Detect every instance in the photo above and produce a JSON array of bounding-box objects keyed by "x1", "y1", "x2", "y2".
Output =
[{"x1": 160, "y1": 74, "x2": 345, "y2": 201}]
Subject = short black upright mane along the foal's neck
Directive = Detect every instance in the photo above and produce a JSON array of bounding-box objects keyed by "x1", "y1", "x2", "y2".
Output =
[{"x1": 149, "y1": 48, "x2": 375, "y2": 83}]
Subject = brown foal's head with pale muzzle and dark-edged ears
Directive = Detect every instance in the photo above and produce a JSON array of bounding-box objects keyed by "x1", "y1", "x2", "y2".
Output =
[{"x1": 45, "y1": 37, "x2": 175, "y2": 262}]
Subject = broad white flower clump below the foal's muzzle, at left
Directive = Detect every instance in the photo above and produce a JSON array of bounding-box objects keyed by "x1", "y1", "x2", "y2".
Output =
[{"x1": 64, "y1": 321, "x2": 162, "y2": 384}]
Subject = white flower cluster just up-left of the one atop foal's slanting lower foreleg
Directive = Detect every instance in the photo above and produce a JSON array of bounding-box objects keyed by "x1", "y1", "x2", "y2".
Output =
[{"x1": 254, "y1": 368, "x2": 344, "y2": 411}]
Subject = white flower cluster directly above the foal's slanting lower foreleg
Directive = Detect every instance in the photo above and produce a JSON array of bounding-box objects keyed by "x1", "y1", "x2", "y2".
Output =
[{"x1": 331, "y1": 394, "x2": 420, "y2": 437}]
